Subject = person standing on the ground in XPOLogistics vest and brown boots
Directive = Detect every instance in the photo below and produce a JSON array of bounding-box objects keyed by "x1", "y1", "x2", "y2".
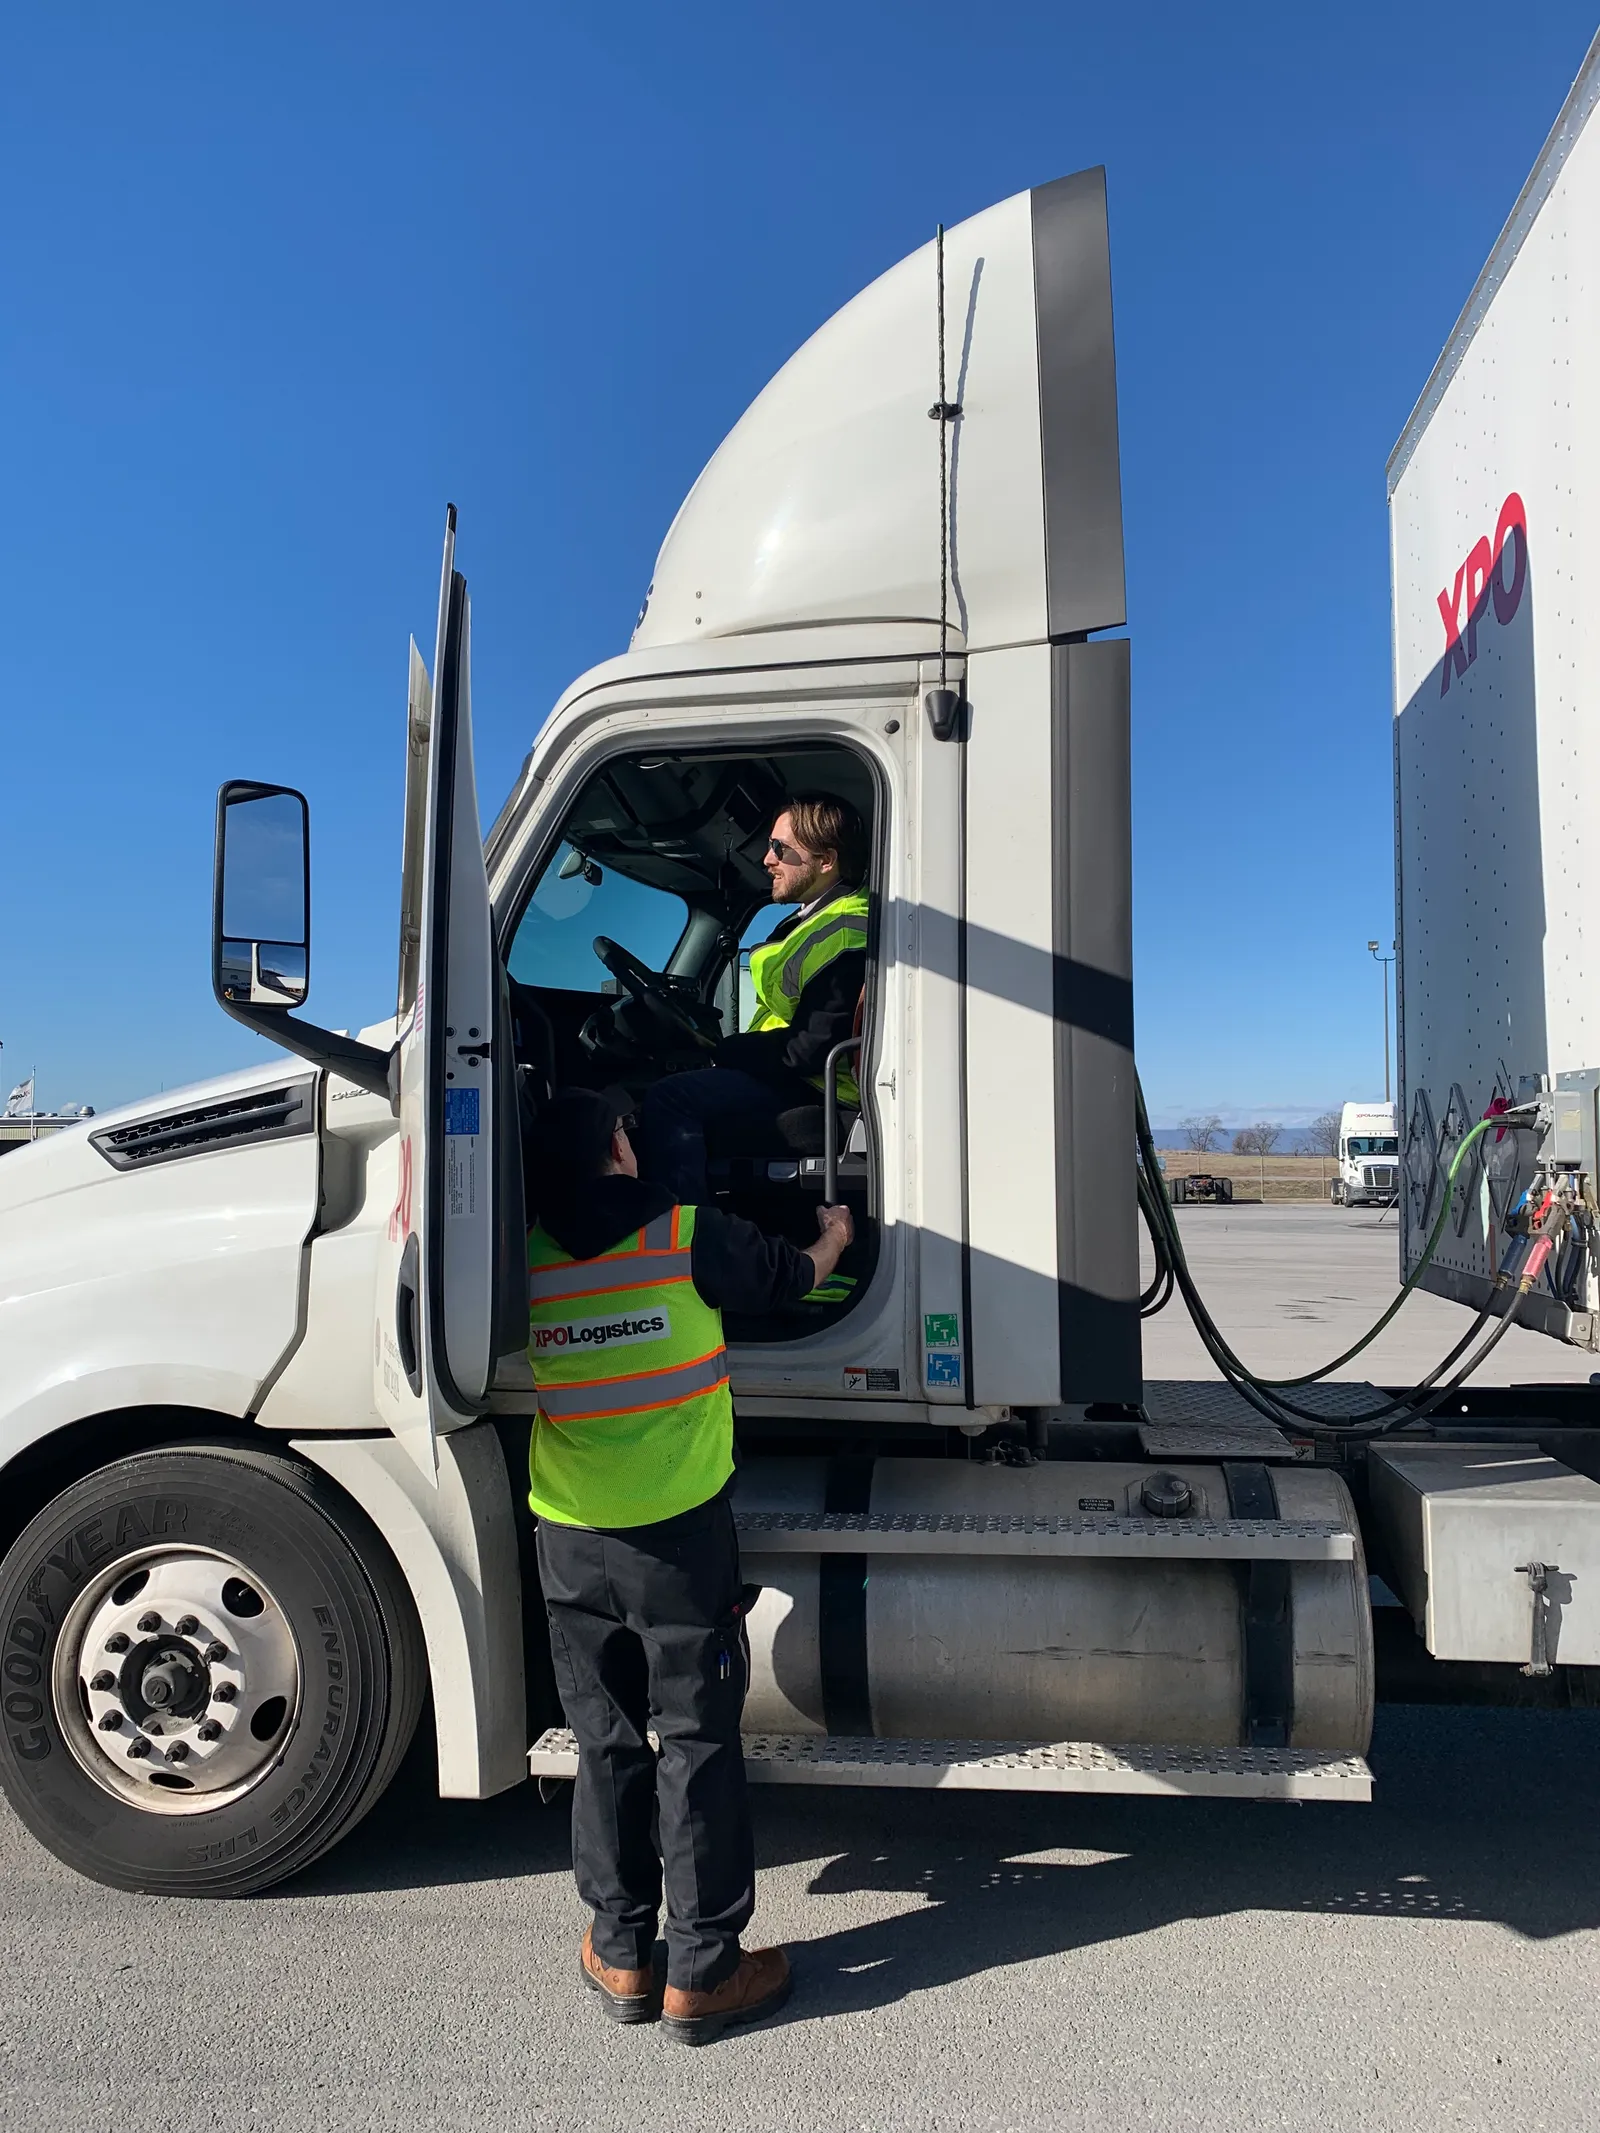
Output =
[{"x1": 527, "y1": 1088, "x2": 851, "y2": 2043}]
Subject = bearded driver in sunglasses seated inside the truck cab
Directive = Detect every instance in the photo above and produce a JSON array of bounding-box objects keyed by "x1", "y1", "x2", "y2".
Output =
[{"x1": 640, "y1": 793, "x2": 870, "y2": 1201}]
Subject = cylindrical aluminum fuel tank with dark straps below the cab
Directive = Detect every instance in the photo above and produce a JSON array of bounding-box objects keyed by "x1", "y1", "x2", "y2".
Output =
[{"x1": 734, "y1": 1457, "x2": 1374, "y2": 1753}]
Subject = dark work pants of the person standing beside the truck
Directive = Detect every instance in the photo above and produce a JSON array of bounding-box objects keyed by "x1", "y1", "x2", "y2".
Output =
[{"x1": 538, "y1": 1495, "x2": 755, "y2": 1992}]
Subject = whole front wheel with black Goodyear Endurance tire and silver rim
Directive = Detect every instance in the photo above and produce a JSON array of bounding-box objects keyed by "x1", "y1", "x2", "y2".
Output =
[{"x1": 0, "y1": 1444, "x2": 427, "y2": 1896}]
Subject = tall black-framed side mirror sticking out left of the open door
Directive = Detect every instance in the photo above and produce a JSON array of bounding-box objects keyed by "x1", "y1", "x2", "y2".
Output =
[{"x1": 211, "y1": 779, "x2": 311, "y2": 1007}]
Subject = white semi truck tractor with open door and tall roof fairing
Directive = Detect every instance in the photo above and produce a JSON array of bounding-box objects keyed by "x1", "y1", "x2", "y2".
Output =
[{"x1": 0, "y1": 50, "x2": 1600, "y2": 1894}]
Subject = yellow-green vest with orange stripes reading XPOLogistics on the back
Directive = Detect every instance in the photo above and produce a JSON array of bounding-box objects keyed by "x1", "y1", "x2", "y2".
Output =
[{"x1": 527, "y1": 1207, "x2": 734, "y2": 1525}]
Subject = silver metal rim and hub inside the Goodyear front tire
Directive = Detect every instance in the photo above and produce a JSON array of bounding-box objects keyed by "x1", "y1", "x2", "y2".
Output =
[{"x1": 55, "y1": 1551, "x2": 301, "y2": 1815}]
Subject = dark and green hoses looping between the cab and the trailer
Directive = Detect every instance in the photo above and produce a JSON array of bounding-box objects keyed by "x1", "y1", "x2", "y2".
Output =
[{"x1": 1135, "y1": 1079, "x2": 1555, "y2": 1438}]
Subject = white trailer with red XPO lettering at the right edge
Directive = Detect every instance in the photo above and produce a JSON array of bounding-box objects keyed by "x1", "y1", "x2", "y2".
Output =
[{"x1": 1389, "y1": 41, "x2": 1600, "y2": 1348}]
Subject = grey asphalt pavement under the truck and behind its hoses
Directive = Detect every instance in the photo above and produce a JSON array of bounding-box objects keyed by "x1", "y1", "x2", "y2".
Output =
[{"x1": 0, "y1": 1207, "x2": 1600, "y2": 2133}]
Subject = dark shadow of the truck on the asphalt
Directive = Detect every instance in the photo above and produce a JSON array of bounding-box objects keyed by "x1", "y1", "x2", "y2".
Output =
[{"x1": 298, "y1": 1706, "x2": 1600, "y2": 1996}]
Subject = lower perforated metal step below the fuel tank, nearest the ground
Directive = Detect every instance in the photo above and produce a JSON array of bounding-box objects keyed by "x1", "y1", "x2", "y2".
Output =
[{"x1": 527, "y1": 1728, "x2": 1372, "y2": 1800}]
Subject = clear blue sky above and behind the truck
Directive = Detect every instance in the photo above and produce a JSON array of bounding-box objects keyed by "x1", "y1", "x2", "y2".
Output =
[{"x1": 0, "y1": 0, "x2": 1594, "y2": 1122}]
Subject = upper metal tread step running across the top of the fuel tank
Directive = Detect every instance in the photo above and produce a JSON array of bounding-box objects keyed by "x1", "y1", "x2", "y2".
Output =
[{"x1": 734, "y1": 1510, "x2": 1355, "y2": 1563}]
